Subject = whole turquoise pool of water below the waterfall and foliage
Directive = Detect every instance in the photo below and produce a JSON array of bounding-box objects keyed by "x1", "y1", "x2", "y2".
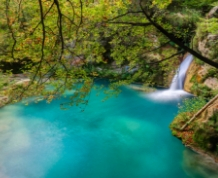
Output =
[{"x1": 0, "y1": 82, "x2": 218, "y2": 178}]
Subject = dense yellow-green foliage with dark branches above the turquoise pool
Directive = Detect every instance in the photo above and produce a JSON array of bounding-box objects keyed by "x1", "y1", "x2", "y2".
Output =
[{"x1": 0, "y1": 0, "x2": 218, "y2": 104}]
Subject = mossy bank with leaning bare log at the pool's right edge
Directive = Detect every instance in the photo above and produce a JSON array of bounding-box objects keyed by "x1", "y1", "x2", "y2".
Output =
[{"x1": 170, "y1": 95, "x2": 218, "y2": 163}]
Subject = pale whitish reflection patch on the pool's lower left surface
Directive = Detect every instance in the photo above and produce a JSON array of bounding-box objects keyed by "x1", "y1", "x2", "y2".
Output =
[{"x1": 0, "y1": 106, "x2": 63, "y2": 178}]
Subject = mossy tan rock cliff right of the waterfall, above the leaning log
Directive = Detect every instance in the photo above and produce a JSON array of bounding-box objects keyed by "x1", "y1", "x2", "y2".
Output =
[{"x1": 184, "y1": 6, "x2": 218, "y2": 94}]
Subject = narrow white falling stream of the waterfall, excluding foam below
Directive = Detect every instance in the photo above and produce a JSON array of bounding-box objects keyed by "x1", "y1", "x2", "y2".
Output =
[{"x1": 170, "y1": 54, "x2": 193, "y2": 90}]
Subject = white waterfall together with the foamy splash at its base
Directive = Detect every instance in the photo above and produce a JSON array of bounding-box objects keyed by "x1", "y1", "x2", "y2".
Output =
[{"x1": 146, "y1": 54, "x2": 193, "y2": 101}]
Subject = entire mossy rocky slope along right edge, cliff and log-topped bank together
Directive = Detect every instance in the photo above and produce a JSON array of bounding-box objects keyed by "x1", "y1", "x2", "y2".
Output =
[{"x1": 170, "y1": 7, "x2": 218, "y2": 162}]
